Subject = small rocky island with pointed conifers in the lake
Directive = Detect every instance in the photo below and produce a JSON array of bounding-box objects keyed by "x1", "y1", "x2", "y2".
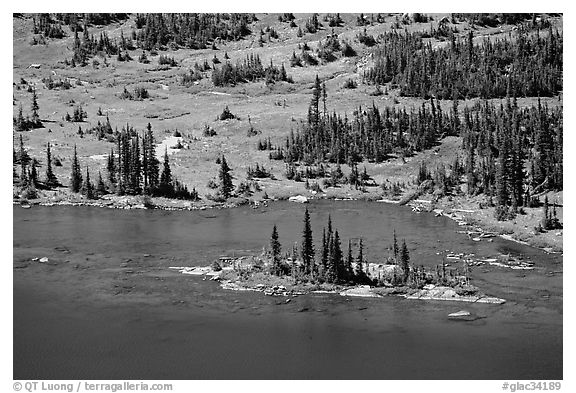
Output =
[{"x1": 171, "y1": 208, "x2": 505, "y2": 304}]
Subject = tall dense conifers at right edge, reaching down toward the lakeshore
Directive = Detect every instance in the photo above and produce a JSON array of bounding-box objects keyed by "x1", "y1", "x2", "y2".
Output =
[{"x1": 460, "y1": 99, "x2": 563, "y2": 219}]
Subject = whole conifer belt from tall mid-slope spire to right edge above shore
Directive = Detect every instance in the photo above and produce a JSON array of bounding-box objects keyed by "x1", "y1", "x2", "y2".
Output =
[{"x1": 270, "y1": 73, "x2": 563, "y2": 219}]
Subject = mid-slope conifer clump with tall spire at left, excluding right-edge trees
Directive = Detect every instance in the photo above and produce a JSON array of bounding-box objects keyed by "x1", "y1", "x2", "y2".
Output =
[{"x1": 270, "y1": 77, "x2": 458, "y2": 165}]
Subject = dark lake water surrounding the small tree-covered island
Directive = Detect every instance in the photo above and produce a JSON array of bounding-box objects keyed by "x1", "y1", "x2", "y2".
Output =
[{"x1": 13, "y1": 201, "x2": 563, "y2": 379}]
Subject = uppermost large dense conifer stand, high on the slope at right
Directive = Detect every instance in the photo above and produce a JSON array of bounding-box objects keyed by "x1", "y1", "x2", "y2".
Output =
[{"x1": 364, "y1": 26, "x2": 563, "y2": 99}]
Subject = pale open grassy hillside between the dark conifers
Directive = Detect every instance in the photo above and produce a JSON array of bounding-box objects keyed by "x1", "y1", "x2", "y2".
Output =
[{"x1": 13, "y1": 14, "x2": 562, "y2": 248}]
